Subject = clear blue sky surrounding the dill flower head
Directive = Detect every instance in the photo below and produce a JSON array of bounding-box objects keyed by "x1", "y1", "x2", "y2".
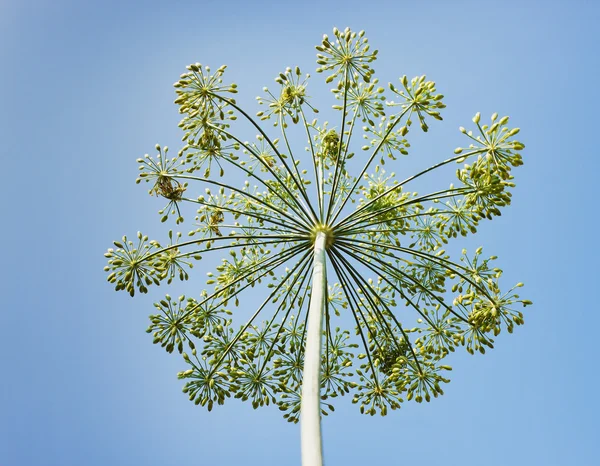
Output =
[{"x1": 0, "y1": 0, "x2": 600, "y2": 466}]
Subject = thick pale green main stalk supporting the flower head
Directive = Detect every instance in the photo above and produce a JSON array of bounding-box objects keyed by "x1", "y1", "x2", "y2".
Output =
[{"x1": 300, "y1": 232, "x2": 327, "y2": 466}]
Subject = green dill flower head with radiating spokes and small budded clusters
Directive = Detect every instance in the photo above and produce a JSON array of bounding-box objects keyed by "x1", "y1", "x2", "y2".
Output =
[{"x1": 105, "y1": 25, "x2": 531, "y2": 422}]
